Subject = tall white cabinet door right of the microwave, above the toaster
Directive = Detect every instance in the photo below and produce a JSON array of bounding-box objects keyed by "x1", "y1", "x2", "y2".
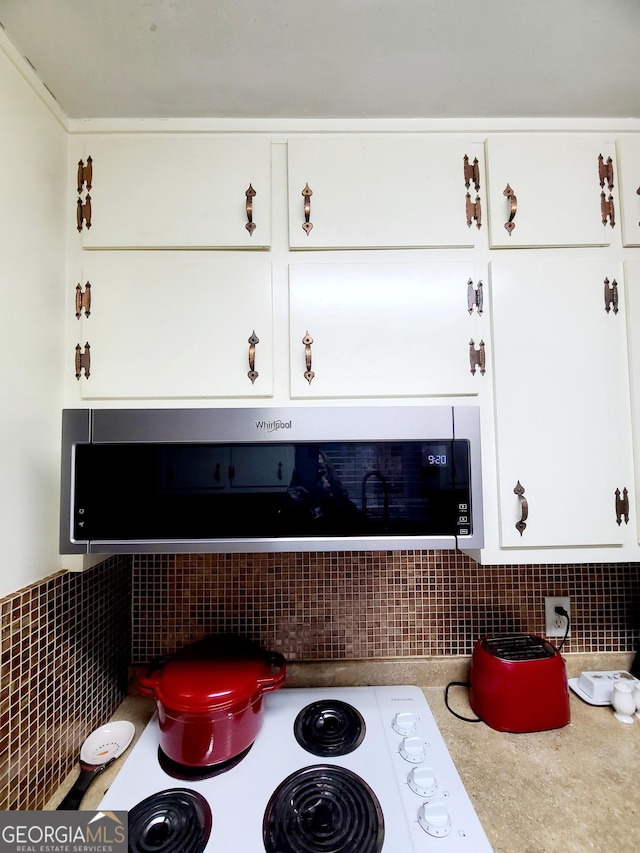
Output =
[{"x1": 491, "y1": 257, "x2": 635, "y2": 548}]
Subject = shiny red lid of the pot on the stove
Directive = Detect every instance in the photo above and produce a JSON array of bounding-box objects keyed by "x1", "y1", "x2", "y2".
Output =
[{"x1": 141, "y1": 656, "x2": 284, "y2": 714}]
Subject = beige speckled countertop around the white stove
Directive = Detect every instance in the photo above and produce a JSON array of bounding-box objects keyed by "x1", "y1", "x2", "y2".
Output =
[{"x1": 47, "y1": 654, "x2": 640, "y2": 853}]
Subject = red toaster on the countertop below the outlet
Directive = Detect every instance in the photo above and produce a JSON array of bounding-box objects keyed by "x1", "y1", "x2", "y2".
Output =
[{"x1": 469, "y1": 634, "x2": 571, "y2": 732}]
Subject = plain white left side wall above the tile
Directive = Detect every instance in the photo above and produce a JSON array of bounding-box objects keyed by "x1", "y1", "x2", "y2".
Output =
[{"x1": 0, "y1": 33, "x2": 68, "y2": 597}]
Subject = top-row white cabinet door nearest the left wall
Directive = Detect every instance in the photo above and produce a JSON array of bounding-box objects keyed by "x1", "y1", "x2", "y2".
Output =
[{"x1": 77, "y1": 133, "x2": 271, "y2": 249}]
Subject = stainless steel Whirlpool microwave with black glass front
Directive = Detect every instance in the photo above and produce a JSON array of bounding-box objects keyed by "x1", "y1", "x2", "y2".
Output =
[{"x1": 60, "y1": 406, "x2": 483, "y2": 554}]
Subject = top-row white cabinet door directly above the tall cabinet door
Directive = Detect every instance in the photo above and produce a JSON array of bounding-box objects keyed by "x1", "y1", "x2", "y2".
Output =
[{"x1": 487, "y1": 133, "x2": 619, "y2": 248}]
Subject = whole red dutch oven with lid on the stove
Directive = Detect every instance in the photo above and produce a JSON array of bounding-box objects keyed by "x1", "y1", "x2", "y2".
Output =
[{"x1": 140, "y1": 641, "x2": 286, "y2": 768}]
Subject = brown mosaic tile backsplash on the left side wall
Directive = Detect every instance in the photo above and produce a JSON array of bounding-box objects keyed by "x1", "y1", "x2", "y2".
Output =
[{"x1": 0, "y1": 557, "x2": 131, "y2": 811}]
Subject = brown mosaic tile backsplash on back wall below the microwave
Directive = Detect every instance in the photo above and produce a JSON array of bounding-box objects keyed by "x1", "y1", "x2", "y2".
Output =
[{"x1": 132, "y1": 551, "x2": 640, "y2": 663}]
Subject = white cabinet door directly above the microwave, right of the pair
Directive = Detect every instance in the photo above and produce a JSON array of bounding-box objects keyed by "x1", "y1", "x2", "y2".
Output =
[{"x1": 289, "y1": 262, "x2": 489, "y2": 398}]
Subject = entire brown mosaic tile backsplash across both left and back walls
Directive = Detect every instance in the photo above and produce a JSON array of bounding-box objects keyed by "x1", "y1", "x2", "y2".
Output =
[{"x1": 0, "y1": 551, "x2": 640, "y2": 810}]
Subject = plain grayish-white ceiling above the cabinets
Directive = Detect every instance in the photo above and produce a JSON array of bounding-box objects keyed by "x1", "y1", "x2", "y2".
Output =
[{"x1": 0, "y1": 0, "x2": 640, "y2": 119}]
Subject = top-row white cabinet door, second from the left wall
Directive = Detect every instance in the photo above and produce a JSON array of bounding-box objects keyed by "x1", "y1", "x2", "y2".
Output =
[{"x1": 288, "y1": 134, "x2": 484, "y2": 249}]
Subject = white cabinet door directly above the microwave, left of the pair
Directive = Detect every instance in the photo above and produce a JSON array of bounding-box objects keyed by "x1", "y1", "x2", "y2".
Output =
[{"x1": 72, "y1": 252, "x2": 273, "y2": 400}]
